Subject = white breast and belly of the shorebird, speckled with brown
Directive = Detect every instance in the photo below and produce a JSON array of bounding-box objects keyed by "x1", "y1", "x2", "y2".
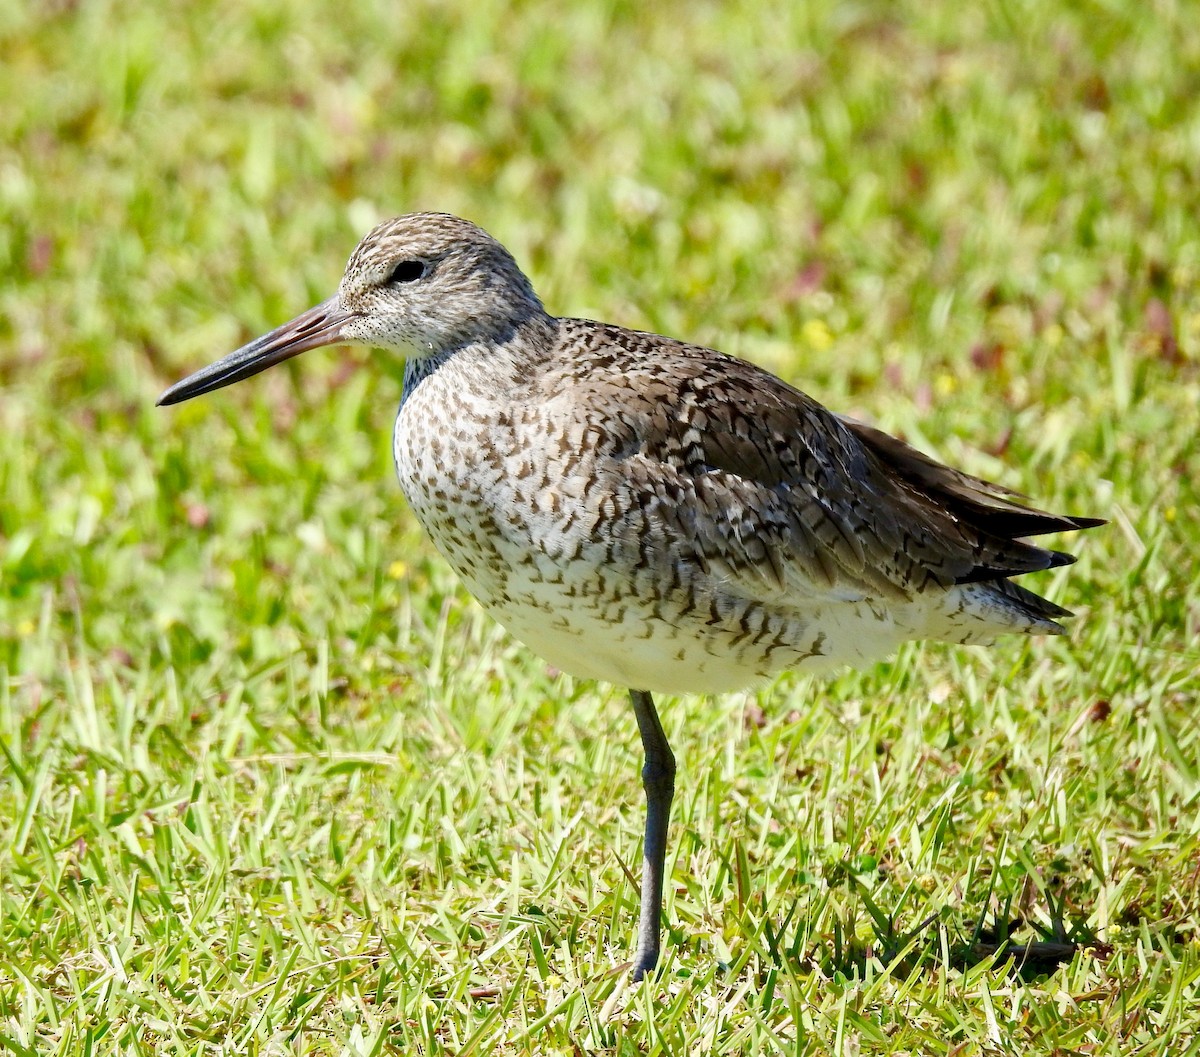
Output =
[{"x1": 394, "y1": 364, "x2": 868, "y2": 692}]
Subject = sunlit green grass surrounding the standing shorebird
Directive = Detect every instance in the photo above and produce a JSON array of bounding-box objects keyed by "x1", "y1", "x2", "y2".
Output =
[{"x1": 0, "y1": 0, "x2": 1200, "y2": 1057}]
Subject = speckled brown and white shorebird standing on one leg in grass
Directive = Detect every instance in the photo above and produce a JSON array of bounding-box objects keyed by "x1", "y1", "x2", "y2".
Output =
[{"x1": 158, "y1": 212, "x2": 1103, "y2": 979}]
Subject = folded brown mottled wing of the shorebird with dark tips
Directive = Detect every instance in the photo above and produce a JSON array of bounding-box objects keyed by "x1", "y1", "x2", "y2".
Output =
[{"x1": 544, "y1": 324, "x2": 1097, "y2": 608}]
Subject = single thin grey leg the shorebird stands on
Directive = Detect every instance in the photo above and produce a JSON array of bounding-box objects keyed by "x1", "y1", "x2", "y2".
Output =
[{"x1": 629, "y1": 690, "x2": 674, "y2": 980}]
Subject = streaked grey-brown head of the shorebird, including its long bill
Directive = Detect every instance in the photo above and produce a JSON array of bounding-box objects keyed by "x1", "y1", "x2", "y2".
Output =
[{"x1": 158, "y1": 212, "x2": 545, "y2": 404}]
